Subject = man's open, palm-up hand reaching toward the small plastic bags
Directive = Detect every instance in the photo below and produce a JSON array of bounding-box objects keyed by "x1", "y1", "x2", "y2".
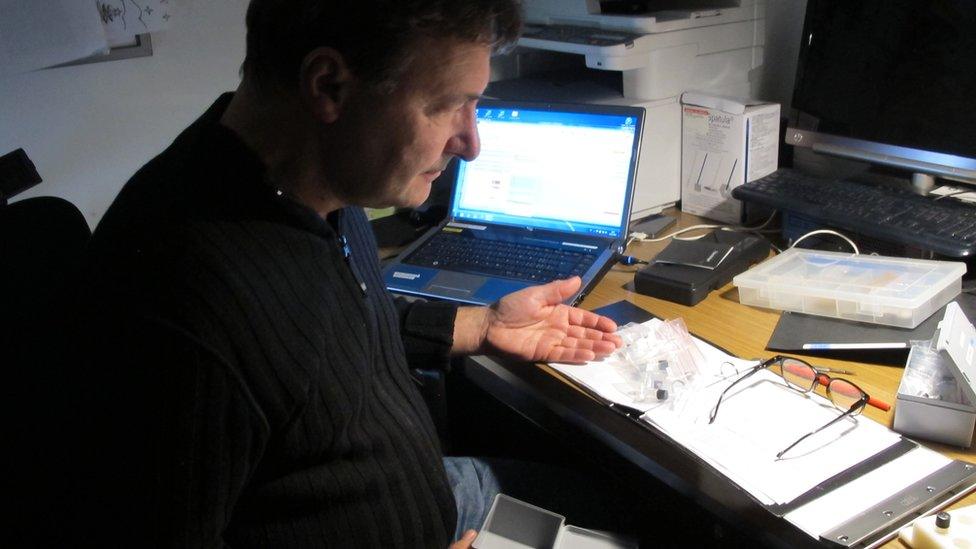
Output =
[{"x1": 454, "y1": 277, "x2": 621, "y2": 362}]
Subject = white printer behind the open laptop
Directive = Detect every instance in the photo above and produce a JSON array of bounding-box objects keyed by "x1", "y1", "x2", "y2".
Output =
[{"x1": 486, "y1": 0, "x2": 765, "y2": 220}]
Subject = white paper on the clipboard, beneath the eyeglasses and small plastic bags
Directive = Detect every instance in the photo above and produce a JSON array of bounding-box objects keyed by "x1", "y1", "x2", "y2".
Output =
[{"x1": 553, "y1": 319, "x2": 901, "y2": 504}]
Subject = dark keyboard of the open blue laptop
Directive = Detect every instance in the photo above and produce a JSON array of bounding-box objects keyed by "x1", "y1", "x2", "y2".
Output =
[{"x1": 403, "y1": 232, "x2": 597, "y2": 283}]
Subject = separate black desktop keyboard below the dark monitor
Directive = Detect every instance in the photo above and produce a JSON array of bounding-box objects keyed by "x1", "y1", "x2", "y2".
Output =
[{"x1": 732, "y1": 169, "x2": 976, "y2": 257}]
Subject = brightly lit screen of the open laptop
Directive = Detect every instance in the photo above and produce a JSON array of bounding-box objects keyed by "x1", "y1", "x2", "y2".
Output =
[{"x1": 451, "y1": 101, "x2": 643, "y2": 238}]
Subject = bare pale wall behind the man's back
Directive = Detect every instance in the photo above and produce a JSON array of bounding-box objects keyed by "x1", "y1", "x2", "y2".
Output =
[{"x1": 0, "y1": 0, "x2": 247, "y2": 227}]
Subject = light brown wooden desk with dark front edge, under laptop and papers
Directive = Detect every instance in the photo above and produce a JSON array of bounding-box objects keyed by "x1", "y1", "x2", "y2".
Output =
[{"x1": 465, "y1": 211, "x2": 976, "y2": 548}]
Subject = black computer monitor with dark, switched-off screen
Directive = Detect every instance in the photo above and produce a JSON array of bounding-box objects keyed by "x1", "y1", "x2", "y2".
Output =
[{"x1": 785, "y1": 0, "x2": 976, "y2": 191}]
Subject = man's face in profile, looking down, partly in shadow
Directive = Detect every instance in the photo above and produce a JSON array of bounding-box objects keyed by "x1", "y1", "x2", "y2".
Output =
[{"x1": 323, "y1": 40, "x2": 491, "y2": 207}]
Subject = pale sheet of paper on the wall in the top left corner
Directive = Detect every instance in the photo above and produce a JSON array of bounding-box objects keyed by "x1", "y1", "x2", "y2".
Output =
[{"x1": 0, "y1": 0, "x2": 108, "y2": 74}]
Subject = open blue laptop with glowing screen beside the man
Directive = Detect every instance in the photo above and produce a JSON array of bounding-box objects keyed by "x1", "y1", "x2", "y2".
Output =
[{"x1": 383, "y1": 100, "x2": 644, "y2": 305}]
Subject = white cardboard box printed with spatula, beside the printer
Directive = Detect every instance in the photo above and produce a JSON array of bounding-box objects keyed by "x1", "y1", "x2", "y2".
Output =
[{"x1": 681, "y1": 92, "x2": 779, "y2": 224}]
